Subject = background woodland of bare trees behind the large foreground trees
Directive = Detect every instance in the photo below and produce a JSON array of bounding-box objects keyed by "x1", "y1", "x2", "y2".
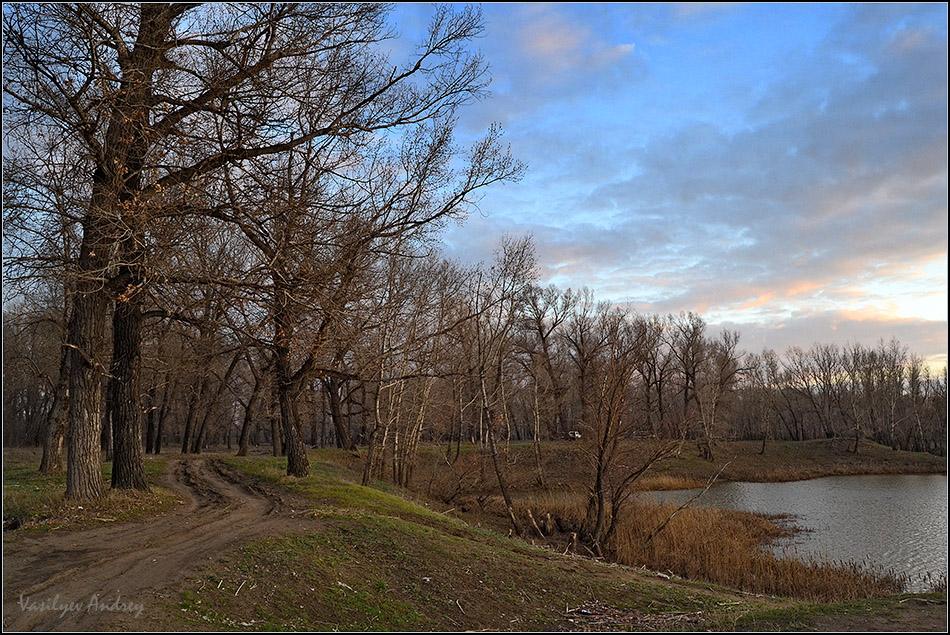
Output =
[{"x1": 4, "y1": 248, "x2": 947, "y2": 458}]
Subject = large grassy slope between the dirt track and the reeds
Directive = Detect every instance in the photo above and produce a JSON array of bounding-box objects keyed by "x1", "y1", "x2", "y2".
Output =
[{"x1": 192, "y1": 457, "x2": 788, "y2": 631}]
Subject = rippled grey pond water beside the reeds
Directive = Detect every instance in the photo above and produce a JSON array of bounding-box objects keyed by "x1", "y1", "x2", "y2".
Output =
[{"x1": 650, "y1": 474, "x2": 947, "y2": 591}]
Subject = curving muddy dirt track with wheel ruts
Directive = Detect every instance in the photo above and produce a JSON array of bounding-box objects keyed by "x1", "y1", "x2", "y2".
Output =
[{"x1": 3, "y1": 456, "x2": 319, "y2": 631}]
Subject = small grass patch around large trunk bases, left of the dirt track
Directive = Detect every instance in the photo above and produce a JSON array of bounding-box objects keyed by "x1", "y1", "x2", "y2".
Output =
[{"x1": 3, "y1": 448, "x2": 178, "y2": 531}]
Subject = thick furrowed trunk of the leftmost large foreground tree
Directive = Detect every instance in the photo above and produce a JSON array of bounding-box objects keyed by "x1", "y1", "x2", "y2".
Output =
[{"x1": 66, "y1": 4, "x2": 173, "y2": 499}]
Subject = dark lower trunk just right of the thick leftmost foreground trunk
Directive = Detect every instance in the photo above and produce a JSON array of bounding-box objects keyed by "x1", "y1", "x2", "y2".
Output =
[{"x1": 109, "y1": 297, "x2": 148, "y2": 490}]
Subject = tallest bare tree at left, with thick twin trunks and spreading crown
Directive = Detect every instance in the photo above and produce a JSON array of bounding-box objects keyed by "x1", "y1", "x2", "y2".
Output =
[{"x1": 4, "y1": 3, "x2": 524, "y2": 498}]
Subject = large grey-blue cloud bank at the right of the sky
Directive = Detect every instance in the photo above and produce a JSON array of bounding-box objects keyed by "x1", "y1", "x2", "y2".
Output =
[{"x1": 560, "y1": 6, "x2": 947, "y2": 301}]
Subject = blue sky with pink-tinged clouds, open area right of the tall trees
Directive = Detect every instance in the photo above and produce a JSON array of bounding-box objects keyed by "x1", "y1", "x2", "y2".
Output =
[{"x1": 392, "y1": 3, "x2": 948, "y2": 367}]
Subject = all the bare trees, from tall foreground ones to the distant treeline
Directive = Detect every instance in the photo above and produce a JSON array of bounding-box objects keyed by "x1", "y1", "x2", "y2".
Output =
[{"x1": 3, "y1": 3, "x2": 947, "y2": 512}]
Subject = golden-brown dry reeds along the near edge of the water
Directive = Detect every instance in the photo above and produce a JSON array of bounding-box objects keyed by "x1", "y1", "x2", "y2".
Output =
[{"x1": 494, "y1": 491, "x2": 906, "y2": 602}]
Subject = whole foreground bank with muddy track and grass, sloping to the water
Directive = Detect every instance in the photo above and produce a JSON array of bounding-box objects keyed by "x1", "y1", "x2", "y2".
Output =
[{"x1": 4, "y1": 452, "x2": 946, "y2": 631}]
